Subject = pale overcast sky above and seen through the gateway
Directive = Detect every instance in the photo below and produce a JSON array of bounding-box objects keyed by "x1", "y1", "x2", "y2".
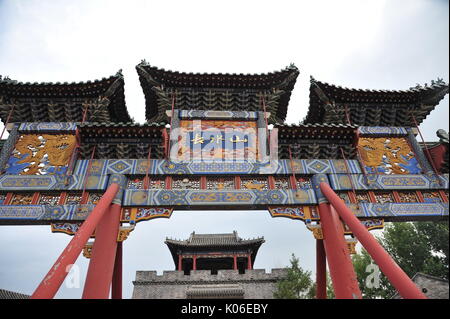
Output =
[{"x1": 0, "y1": 0, "x2": 449, "y2": 298}]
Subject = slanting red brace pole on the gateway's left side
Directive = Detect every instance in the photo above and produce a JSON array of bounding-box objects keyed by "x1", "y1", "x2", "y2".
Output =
[{"x1": 31, "y1": 183, "x2": 119, "y2": 299}]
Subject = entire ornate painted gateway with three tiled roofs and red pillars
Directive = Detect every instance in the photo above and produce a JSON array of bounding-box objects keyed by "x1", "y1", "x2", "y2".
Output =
[{"x1": 0, "y1": 61, "x2": 449, "y2": 298}]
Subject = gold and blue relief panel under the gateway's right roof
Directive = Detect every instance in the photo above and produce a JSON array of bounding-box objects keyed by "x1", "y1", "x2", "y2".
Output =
[{"x1": 358, "y1": 137, "x2": 421, "y2": 174}]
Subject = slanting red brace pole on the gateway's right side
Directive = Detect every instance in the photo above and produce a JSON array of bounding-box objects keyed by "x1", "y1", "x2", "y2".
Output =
[{"x1": 320, "y1": 183, "x2": 426, "y2": 299}]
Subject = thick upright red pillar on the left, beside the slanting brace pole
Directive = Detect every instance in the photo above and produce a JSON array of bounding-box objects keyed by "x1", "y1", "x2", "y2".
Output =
[{"x1": 82, "y1": 204, "x2": 121, "y2": 299}]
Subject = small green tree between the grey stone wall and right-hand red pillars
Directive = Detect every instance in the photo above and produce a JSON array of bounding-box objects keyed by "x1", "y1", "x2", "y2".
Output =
[{"x1": 273, "y1": 254, "x2": 314, "y2": 299}]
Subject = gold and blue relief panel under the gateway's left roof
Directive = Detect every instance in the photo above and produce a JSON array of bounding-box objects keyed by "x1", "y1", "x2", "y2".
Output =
[{"x1": 6, "y1": 134, "x2": 75, "y2": 175}]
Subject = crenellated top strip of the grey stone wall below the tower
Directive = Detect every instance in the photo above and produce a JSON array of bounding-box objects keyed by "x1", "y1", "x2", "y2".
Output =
[{"x1": 133, "y1": 268, "x2": 287, "y2": 285}]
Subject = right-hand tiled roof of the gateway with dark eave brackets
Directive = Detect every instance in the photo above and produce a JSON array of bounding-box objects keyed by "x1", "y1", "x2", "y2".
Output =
[{"x1": 304, "y1": 77, "x2": 449, "y2": 127}]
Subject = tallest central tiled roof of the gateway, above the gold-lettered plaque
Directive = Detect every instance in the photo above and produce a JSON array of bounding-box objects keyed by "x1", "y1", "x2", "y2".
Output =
[{"x1": 136, "y1": 61, "x2": 300, "y2": 123}]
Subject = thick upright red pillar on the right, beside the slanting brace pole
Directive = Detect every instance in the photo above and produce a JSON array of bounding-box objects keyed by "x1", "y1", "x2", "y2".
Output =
[{"x1": 319, "y1": 203, "x2": 362, "y2": 299}]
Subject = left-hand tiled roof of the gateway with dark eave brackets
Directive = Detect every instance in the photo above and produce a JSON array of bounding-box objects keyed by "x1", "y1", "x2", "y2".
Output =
[{"x1": 0, "y1": 71, "x2": 131, "y2": 123}]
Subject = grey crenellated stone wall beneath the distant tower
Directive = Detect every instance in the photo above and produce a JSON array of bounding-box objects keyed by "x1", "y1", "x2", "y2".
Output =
[{"x1": 132, "y1": 269, "x2": 287, "y2": 299}]
